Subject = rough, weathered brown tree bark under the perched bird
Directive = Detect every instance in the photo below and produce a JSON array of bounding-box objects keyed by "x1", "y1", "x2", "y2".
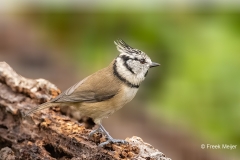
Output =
[{"x1": 0, "y1": 62, "x2": 170, "y2": 160}]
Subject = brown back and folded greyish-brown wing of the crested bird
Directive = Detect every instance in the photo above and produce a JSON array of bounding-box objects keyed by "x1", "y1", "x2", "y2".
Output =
[{"x1": 51, "y1": 67, "x2": 120, "y2": 103}]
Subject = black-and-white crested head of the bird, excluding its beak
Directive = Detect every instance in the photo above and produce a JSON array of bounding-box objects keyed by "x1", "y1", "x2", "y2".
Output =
[{"x1": 114, "y1": 40, "x2": 152, "y2": 88}]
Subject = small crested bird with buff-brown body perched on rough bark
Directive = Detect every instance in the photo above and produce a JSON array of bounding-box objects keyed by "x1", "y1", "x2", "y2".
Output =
[{"x1": 24, "y1": 39, "x2": 160, "y2": 147}]
